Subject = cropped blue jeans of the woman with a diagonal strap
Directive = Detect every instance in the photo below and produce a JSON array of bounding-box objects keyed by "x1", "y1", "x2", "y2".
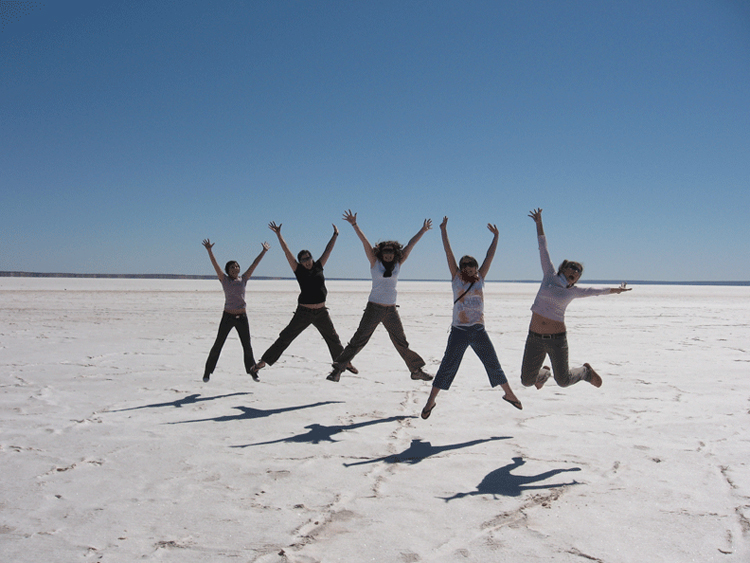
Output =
[{"x1": 432, "y1": 325, "x2": 508, "y2": 391}]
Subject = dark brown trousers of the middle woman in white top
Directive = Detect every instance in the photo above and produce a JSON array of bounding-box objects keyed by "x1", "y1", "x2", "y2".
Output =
[{"x1": 334, "y1": 301, "x2": 425, "y2": 373}]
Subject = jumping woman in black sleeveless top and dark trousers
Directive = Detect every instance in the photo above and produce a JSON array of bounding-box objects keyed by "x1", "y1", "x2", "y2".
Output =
[{"x1": 252, "y1": 221, "x2": 357, "y2": 376}]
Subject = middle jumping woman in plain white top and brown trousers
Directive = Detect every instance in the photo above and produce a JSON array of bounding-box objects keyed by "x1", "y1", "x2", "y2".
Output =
[{"x1": 326, "y1": 210, "x2": 432, "y2": 381}]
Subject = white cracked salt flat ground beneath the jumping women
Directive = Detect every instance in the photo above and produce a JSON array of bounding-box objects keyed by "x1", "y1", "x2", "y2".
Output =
[{"x1": 0, "y1": 278, "x2": 750, "y2": 563}]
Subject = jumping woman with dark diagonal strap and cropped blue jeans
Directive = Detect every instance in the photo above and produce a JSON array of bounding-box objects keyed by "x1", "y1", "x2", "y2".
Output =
[{"x1": 421, "y1": 217, "x2": 523, "y2": 419}]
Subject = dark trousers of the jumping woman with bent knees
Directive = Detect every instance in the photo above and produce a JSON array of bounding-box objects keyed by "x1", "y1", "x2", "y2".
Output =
[{"x1": 521, "y1": 332, "x2": 588, "y2": 387}]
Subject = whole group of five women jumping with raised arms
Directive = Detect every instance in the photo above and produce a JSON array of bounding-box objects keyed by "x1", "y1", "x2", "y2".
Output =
[{"x1": 203, "y1": 209, "x2": 630, "y2": 419}]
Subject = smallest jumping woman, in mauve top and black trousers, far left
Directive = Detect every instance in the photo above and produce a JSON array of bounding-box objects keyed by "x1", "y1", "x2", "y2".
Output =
[{"x1": 203, "y1": 239, "x2": 271, "y2": 382}]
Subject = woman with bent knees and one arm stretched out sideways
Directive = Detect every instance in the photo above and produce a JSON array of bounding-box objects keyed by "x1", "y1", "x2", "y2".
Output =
[{"x1": 521, "y1": 209, "x2": 630, "y2": 389}]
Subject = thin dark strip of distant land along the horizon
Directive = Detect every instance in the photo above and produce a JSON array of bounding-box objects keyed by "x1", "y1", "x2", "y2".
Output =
[{"x1": 0, "y1": 272, "x2": 750, "y2": 286}]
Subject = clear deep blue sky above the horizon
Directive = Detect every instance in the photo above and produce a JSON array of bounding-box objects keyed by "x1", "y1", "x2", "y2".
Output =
[{"x1": 0, "y1": 0, "x2": 750, "y2": 282}]
